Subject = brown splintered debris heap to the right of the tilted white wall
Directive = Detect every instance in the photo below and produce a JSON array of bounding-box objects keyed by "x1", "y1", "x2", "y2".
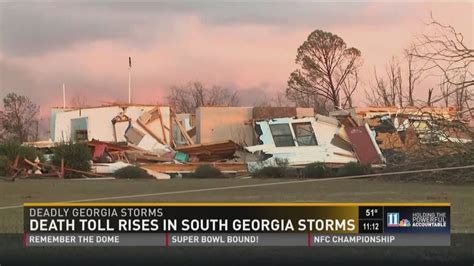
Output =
[{"x1": 331, "y1": 107, "x2": 474, "y2": 164}]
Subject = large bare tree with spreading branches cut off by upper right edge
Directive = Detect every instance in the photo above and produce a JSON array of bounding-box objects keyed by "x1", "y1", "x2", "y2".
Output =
[{"x1": 409, "y1": 16, "x2": 474, "y2": 104}]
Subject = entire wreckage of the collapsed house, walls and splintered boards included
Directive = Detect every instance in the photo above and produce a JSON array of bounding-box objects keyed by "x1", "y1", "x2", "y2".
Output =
[{"x1": 13, "y1": 104, "x2": 466, "y2": 179}]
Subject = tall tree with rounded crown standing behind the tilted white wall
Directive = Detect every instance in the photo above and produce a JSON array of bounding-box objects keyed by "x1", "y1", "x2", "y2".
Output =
[{"x1": 286, "y1": 30, "x2": 361, "y2": 108}]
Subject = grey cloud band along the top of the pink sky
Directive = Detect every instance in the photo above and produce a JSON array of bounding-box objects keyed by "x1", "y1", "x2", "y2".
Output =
[{"x1": 0, "y1": 1, "x2": 426, "y2": 56}]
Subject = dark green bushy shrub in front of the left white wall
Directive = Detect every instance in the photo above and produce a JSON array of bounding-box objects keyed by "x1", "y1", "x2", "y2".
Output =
[{"x1": 52, "y1": 143, "x2": 92, "y2": 178}]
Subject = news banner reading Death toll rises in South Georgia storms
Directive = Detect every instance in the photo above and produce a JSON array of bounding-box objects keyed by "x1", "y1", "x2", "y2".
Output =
[{"x1": 24, "y1": 203, "x2": 451, "y2": 247}]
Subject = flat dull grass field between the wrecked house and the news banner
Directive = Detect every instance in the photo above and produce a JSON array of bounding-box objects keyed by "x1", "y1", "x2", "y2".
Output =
[{"x1": 0, "y1": 179, "x2": 474, "y2": 233}]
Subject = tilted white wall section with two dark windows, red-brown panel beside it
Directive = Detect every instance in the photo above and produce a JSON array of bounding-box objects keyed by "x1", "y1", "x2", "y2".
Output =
[{"x1": 246, "y1": 115, "x2": 384, "y2": 169}]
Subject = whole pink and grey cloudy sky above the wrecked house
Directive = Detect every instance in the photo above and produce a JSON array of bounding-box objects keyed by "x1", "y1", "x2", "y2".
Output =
[{"x1": 0, "y1": 2, "x2": 472, "y2": 112}]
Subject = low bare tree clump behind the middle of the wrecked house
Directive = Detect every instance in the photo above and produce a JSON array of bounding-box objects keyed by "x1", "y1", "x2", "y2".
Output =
[{"x1": 168, "y1": 81, "x2": 240, "y2": 113}]
